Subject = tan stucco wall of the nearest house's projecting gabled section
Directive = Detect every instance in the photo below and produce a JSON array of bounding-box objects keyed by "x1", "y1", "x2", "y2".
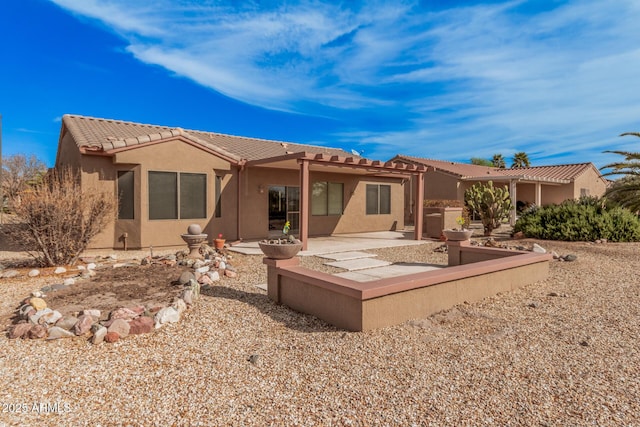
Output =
[{"x1": 71, "y1": 139, "x2": 237, "y2": 248}]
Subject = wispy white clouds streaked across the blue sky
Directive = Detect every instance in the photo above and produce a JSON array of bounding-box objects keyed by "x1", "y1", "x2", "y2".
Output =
[{"x1": 52, "y1": 0, "x2": 640, "y2": 167}]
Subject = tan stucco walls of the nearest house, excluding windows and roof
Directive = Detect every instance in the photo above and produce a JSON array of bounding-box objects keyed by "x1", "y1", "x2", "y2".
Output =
[{"x1": 67, "y1": 137, "x2": 404, "y2": 249}]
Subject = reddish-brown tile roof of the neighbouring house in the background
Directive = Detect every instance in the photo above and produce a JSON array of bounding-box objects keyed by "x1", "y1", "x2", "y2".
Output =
[{"x1": 394, "y1": 155, "x2": 600, "y2": 181}]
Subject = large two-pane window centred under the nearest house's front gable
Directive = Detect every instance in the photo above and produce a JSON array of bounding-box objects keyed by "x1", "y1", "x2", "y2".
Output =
[{"x1": 149, "y1": 171, "x2": 207, "y2": 219}]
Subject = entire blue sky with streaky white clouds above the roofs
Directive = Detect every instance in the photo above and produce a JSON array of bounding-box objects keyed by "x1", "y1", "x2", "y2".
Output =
[{"x1": 0, "y1": 0, "x2": 640, "y2": 171}]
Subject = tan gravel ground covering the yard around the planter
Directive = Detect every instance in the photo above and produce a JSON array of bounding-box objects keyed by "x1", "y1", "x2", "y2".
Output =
[{"x1": 0, "y1": 242, "x2": 640, "y2": 426}]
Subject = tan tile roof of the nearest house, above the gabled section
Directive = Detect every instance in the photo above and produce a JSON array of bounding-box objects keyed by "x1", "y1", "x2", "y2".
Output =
[{"x1": 62, "y1": 115, "x2": 352, "y2": 161}]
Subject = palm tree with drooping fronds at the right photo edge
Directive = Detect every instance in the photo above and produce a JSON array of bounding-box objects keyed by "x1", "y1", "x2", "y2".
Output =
[{"x1": 600, "y1": 132, "x2": 640, "y2": 212}]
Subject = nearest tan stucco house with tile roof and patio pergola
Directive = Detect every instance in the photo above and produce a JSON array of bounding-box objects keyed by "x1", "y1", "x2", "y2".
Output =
[{"x1": 56, "y1": 115, "x2": 425, "y2": 248}]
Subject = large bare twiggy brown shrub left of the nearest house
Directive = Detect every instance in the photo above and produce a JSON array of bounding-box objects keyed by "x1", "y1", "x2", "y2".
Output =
[{"x1": 8, "y1": 169, "x2": 116, "y2": 266}]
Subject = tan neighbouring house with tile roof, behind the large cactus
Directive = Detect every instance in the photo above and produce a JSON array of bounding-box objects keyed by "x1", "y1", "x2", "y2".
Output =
[{"x1": 391, "y1": 155, "x2": 607, "y2": 223}]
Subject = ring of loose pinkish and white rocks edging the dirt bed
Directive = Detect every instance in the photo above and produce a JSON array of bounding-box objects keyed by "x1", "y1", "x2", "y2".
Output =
[{"x1": 7, "y1": 245, "x2": 237, "y2": 344}]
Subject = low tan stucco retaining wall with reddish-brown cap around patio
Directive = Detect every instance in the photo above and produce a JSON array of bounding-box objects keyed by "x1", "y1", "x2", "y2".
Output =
[{"x1": 263, "y1": 242, "x2": 551, "y2": 331}]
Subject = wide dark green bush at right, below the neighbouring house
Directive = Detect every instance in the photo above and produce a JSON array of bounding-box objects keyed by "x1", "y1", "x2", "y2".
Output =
[{"x1": 513, "y1": 198, "x2": 640, "y2": 242}]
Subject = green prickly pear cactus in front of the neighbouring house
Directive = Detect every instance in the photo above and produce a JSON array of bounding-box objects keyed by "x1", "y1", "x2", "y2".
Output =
[{"x1": 464, "y1": 181, "x2": 513, "y2": 236}]
